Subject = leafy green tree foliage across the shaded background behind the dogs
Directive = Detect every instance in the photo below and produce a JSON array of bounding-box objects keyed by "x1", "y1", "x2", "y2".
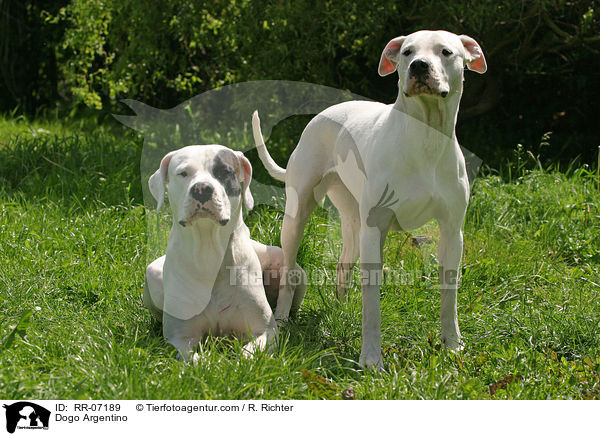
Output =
[{"x1": 0, "y1": 0, "x2": 600, "y2": 165}]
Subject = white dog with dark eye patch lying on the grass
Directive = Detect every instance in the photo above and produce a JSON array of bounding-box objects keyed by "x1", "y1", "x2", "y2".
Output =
[{"x1": 144, "y1": 145, "x2": 304, "y2": 360}]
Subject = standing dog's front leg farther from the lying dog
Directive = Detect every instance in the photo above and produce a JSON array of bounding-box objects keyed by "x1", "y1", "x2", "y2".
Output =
[{"x1": 438, "y1": 222, "x2": 463, "y2": 350}]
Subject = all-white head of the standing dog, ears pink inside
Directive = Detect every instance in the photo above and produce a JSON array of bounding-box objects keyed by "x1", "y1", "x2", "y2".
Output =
[{"x1": 379, "y1": 30, "x2": 487, "y2": 98}]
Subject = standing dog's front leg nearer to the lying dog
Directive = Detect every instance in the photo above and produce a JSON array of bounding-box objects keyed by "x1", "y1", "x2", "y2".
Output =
[{"x1": 359, "y1": 222, "x2": 387, "y2": 369}]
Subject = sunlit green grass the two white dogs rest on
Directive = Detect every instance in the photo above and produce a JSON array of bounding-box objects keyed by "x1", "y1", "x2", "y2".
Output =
[{"x1": 0, "y1": 117, "x2": 600, "y2": 399}]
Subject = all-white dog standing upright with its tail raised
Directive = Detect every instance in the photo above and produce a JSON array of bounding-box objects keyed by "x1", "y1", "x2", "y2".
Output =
[{"x1": 252, "y1": 31, "x2": 487, "y2": 367}]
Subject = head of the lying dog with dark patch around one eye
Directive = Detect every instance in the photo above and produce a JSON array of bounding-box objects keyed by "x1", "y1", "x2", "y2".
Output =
[{"x1": 148, "y1": 145, "x2": 254, "y2": 227}]
